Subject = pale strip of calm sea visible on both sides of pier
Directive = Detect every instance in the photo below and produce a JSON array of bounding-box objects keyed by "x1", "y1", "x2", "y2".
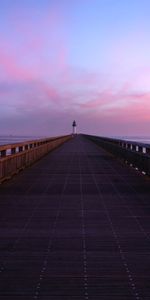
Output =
[{"x1": 0, "y1": 135, "x2": 150, "y2": 145}]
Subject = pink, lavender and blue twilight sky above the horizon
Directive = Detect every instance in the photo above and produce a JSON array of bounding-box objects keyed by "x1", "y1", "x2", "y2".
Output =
[{"x1": 0, "y1": 0, "x2": 150, "y2": 136}]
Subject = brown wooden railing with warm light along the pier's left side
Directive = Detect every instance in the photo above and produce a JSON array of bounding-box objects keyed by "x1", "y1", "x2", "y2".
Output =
[{"x1": 0, "y1": 135, "x2": 71, "y2": 183}]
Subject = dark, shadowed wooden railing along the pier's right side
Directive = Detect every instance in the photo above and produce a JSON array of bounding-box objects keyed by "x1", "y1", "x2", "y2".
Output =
[{"x1": 85, "y1": 135, "x2": 150, "y2": 175}]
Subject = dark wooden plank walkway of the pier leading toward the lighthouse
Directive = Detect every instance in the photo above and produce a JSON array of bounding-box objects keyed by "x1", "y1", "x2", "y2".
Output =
[{"x1": 0, "y1": 135, "x2": 150, "y2": 300}]
